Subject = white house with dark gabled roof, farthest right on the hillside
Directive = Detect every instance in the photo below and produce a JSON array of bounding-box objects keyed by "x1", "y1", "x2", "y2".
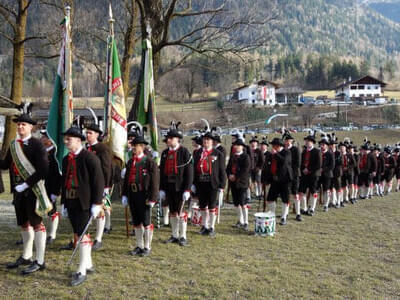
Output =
[{"x1": 335, "y1": 75, "x2": 386, "y2": 99}]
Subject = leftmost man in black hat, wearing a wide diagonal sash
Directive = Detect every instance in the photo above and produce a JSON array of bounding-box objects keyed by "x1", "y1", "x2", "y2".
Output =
[{"x1": 0, "y1": 114, "x2": 52, "y2": 274}]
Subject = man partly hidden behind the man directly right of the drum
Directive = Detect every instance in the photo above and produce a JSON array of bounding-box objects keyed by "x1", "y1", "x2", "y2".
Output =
[{"x1": 282, "y1": 130, "x2": 301, "y2": 221}]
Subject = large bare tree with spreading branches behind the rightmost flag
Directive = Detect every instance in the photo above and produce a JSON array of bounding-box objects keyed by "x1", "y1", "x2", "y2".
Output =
[{"x1": 128, "y1": 0, "x2": 276, "y2": 119}]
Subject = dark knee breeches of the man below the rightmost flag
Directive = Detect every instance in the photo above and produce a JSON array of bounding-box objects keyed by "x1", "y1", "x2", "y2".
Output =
[{"x1": 128, "y1": 191, "x2": 151, "y2": 227}]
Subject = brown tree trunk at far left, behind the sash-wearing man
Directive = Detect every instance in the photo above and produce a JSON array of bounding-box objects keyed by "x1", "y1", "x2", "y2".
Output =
[{"x1": 1, "y1": 0, "x2": 28, "y2": 157}]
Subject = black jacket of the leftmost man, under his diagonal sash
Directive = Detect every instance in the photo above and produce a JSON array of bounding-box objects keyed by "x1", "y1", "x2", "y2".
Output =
[{"x1": 0, "y1": 137, "x2": 49, "y2": 192}]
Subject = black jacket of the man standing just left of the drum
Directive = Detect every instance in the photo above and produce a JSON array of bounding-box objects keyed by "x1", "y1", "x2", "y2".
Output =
[{"x1": 226, "y1": 151, "x2": 250, "y2": 189}]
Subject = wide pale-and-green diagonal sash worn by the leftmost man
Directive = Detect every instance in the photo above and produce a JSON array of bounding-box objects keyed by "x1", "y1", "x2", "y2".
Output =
[{"x1": 10, "y1": 140, "x2": 53, "y2": 217}]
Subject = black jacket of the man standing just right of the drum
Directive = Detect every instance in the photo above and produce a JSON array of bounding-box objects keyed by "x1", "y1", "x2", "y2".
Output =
[{"x1": 261, "y1": 149, "x2": 293, "y2": 184}]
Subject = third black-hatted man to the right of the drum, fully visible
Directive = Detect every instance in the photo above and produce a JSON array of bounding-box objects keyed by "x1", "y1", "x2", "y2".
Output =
[{"x1": 299, "y1": 135, "x2": 321, "y2": 216}]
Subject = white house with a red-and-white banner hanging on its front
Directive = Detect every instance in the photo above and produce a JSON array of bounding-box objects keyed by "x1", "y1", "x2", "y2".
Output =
[{"x1": 234, "y1": 80, "x2": 278, "y2": 106}]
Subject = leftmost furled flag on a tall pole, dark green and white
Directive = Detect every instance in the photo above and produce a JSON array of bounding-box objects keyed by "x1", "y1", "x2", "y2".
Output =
[{"x1": 47, "y1": 16, "x2": 73, "y2": 173}]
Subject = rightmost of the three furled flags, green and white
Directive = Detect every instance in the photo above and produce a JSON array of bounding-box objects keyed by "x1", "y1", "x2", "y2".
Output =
[{"x1": 136, "y1": 39, "x2": 158, "y2": 151}]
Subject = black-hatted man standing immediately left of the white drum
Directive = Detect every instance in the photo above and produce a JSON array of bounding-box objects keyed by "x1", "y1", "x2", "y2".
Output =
[{"x1": 226, "y1": 139, "x2": 251, "y2": 231}]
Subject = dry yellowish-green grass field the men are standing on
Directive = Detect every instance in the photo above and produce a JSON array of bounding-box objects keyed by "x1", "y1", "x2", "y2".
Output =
[{"x1": 0, "y1": 130, "x2": 400, "y2": 299}]
